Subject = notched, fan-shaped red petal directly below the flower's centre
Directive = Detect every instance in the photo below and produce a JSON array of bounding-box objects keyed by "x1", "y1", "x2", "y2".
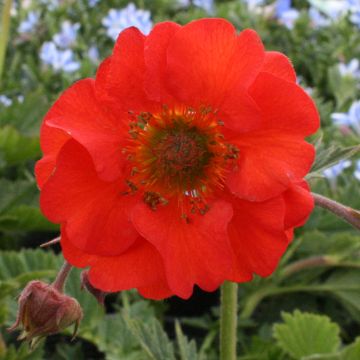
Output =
[{"x1": 132, "y1": 201, "x2": 232, "y2": 298}]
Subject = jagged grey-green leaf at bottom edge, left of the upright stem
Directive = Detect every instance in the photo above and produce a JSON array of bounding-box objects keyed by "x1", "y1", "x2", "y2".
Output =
[{"x1": 124, "y1": 316, "x2": 175, "y2": 360}]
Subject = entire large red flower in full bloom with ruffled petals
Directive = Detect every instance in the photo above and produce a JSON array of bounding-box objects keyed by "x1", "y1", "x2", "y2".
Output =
[{"x1": 36, "y1": 19, "x2": 319, "y2": 299}]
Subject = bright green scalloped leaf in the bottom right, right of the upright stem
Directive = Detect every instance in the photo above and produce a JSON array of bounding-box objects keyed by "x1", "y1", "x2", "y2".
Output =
[{"x1": 273, "y1": 310, "x2": 340, "y2": 360}]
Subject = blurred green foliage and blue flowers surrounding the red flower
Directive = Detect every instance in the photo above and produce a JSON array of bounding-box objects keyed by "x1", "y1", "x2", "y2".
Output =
[{"x1": 0, "y1": 0, "x2": 360, "y2": 360}]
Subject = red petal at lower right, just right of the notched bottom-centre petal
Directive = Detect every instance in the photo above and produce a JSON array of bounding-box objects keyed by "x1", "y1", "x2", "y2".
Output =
[{"x1": 229, "y1": 196, "x2": 288, "y2": 282}]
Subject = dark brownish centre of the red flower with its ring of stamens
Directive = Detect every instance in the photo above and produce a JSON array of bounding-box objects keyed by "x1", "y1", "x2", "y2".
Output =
[{"x1": 126, "y1": 106, "x2": 238, "y2": 211}]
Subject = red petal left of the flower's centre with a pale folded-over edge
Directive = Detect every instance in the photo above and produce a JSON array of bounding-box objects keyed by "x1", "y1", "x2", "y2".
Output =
[{"x1": 45, "y1": 79, "x2": 127, "y2": 180}]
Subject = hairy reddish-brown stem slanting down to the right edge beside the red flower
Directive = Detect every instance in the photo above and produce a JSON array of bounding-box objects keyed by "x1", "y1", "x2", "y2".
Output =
[{"x1": 312, "y1": 193, "x2": 360, "y2": 230}]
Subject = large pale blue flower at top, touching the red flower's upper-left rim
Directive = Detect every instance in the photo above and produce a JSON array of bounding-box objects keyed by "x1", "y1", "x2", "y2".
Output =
[{"x1": 102, "y1": 3, "x2": 153, "y2": 40}]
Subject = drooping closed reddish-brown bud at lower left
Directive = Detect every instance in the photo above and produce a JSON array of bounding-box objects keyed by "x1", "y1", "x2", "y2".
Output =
[{"x1": 9, "y1": 280, "x2": 83, "y2": 345}]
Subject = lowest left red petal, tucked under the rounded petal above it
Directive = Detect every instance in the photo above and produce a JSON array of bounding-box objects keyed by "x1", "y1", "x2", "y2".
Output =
[{"x1": 61, "y1": 229, "x2": 172, "y2": 300}]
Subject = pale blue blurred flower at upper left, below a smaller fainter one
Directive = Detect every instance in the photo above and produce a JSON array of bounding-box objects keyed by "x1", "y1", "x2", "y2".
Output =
[{"x1": 40, "y1": 42, "x2": 80, "y2": 73}]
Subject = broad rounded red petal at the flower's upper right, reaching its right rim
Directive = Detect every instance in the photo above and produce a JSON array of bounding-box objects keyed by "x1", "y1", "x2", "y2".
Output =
[{"x1": 250, "y1": 73, "x2": 319, "y2": 137}]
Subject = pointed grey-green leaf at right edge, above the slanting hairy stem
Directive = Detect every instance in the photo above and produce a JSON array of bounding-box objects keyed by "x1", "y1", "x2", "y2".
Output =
[{"x1": 307, "y1": 145, "x2": 360, "y2": 178}]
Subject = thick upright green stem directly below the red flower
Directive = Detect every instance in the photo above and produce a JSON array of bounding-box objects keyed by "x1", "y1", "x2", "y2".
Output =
[{"x1": 220, "y1": 281, "x2": 238, "y2": 360}]
